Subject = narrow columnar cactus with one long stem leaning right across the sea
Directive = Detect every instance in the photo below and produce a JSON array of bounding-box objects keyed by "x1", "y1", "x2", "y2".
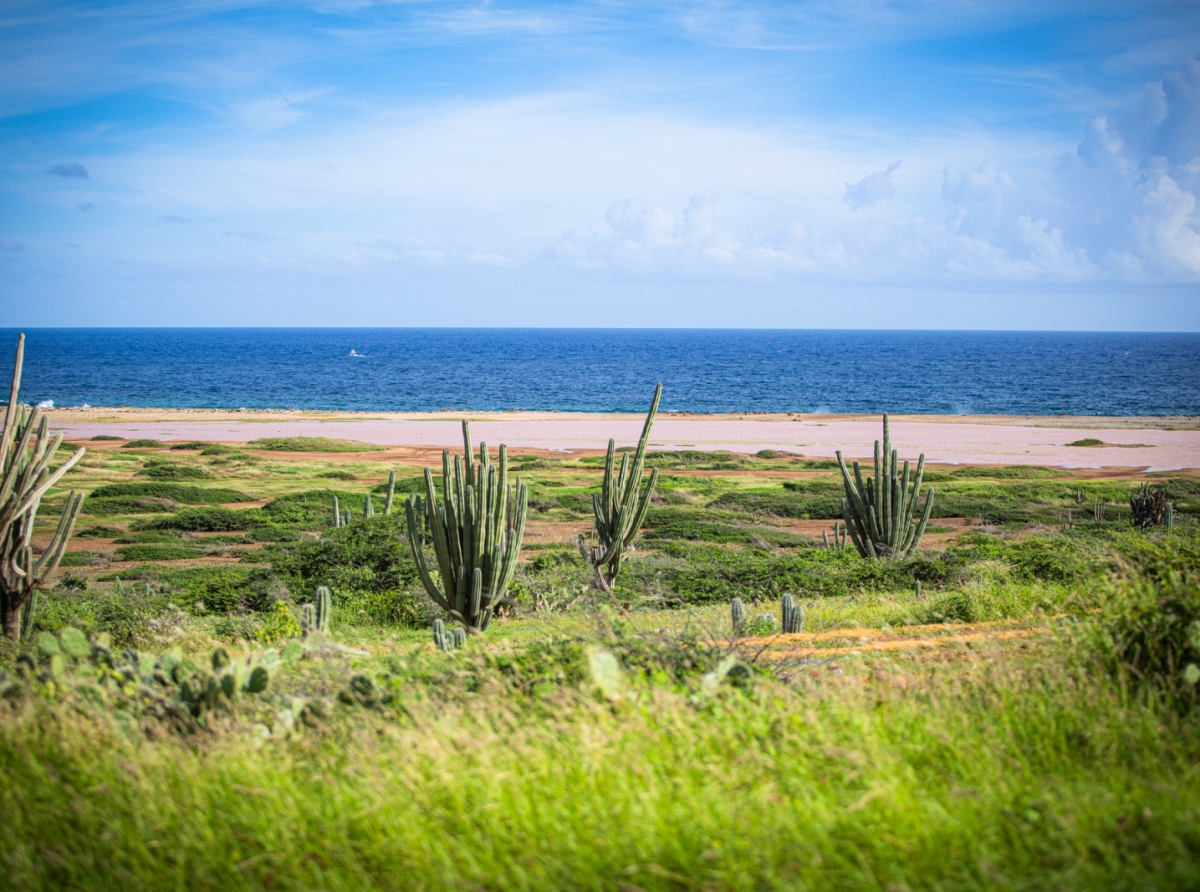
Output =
[{"x1": 578, "y1": 384, "x2": 662, "y2": 592}]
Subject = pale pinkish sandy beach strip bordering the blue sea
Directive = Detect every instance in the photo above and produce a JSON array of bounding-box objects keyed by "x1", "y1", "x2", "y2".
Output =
[{"x1": 49, "y1": 407, "x2": 1200, "y2": 472}]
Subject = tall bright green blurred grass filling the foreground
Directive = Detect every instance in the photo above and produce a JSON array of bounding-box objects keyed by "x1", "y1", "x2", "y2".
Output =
[{"x1": 0, "y1": 654, "x2": 1200, "y2": 890}]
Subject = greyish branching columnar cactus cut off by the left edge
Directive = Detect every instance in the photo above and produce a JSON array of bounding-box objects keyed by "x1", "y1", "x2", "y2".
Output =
[{"x1": 0, "y1": 335, "x2": 84, "y2": 641}]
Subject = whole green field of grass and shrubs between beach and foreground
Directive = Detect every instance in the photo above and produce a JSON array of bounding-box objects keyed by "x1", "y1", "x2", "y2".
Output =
[{"x1": 0, "y1": 443, "x2": 1200, "y2": 892}]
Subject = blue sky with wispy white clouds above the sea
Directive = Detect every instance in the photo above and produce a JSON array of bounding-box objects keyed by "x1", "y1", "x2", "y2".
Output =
[{"x1": 0, "y1": 0, "x2": 1200, "y2": 331}]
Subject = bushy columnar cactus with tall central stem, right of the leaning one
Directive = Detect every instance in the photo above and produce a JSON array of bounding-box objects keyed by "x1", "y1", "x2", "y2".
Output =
[{"x1": 838, "y1": 413, "x2": 934, "y2": 558}]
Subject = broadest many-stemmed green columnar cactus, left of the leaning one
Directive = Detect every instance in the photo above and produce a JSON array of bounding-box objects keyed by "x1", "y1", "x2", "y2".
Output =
[{"x1": 404, "y1": 421, "x2": 529, "y2": 631}]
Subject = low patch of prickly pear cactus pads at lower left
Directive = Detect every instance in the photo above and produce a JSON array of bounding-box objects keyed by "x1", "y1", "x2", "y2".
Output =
[{"x1": 0, "y1": 628, "x2": 280, "y2": 730}]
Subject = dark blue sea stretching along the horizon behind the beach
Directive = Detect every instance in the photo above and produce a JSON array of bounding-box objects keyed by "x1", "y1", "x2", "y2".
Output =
[{"x1": 0, "y1": 329, "x2": 1200, "y2": 415}]
